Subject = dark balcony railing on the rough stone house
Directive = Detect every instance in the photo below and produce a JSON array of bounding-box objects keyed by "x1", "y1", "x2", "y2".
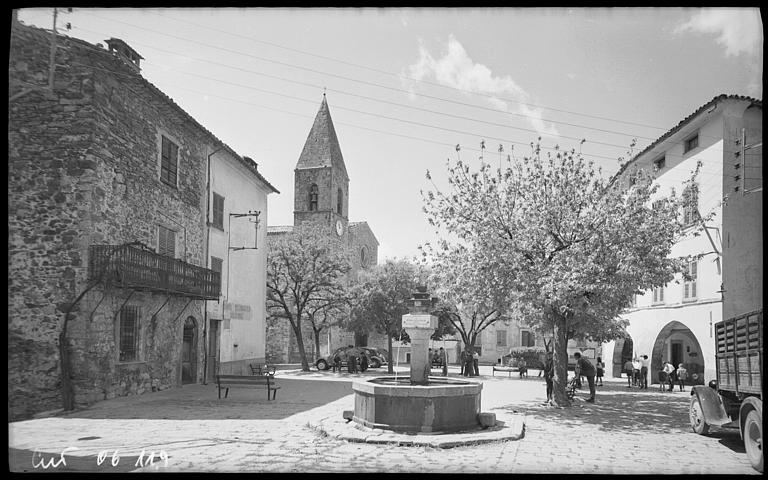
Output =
[{"x1": 88, "y1": 245, "x2": 221, "y2": 300}]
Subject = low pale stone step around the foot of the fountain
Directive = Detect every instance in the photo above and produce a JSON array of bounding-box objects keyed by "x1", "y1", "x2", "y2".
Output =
[{"x1": 307, "y1": 411, "x2": 525, "y2": 448}]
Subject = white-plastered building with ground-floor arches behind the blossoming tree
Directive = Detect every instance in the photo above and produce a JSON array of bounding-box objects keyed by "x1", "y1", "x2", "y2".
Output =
[{"x1": 603, "y1": 95, "x2": 763, "y2": 384}]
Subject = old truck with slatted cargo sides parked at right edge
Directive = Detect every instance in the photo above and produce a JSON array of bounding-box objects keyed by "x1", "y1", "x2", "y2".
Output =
[{"x1": 689, "y1": 309, "x2": 763, "y2": 472}]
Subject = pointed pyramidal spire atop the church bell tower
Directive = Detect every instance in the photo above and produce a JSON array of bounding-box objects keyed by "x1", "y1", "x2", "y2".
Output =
[{"x1": 296, "y1": 92, "x2": 349, "y2": 182}]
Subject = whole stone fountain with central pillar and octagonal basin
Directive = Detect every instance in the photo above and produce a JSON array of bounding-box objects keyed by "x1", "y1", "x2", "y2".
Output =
[{"x1": 352, "y1": 286, "x2": 484, "y2": 434}]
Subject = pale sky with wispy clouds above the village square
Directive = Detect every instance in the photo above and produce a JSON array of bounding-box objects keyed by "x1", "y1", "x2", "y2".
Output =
[{"x1": 19, "y1": 7, "x2": 763, "y2": 263}]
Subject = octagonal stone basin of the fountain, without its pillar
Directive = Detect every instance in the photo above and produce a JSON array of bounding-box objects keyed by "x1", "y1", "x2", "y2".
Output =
[{"x1": 352, "y1": 377, "x2": 483, "y2": 433}]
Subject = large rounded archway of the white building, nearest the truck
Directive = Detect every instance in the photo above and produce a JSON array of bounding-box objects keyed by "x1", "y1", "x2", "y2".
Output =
[{"x1": 648, "y1": 321, "x2": 704, "y2": 385}]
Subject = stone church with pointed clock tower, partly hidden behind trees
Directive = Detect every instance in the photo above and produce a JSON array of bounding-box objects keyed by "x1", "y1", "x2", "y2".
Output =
[{"x1": 267, "y1": 95, "x2": 386, "y2": 363}]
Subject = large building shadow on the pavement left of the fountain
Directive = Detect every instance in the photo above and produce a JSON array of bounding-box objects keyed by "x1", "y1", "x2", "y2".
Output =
[{"x1": 59, "y1": 375, "x2": 352, "y2": 420}]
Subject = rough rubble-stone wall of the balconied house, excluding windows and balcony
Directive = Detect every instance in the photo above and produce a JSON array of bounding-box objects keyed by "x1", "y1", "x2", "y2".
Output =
[{"x1": 8, "y1": 24, "x2": 214, "y2": 418}]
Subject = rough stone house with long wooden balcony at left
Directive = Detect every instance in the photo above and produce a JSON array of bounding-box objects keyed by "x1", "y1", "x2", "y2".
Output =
[{"x1": 8, "y1": 19, "x2": 278, "y2": 419}]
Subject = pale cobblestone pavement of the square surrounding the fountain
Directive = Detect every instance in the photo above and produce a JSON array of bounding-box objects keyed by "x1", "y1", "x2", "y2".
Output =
[{"x1": 9, "y1": 367, "x2": 757, "y2": 474}]
